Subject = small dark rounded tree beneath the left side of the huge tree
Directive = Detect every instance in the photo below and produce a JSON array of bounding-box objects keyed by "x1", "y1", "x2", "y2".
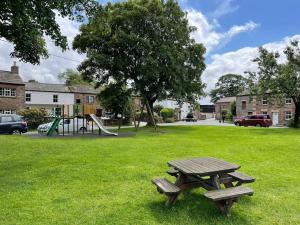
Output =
[{"x1": 97, "y1": 83, "x2": 131, "y2": 118}]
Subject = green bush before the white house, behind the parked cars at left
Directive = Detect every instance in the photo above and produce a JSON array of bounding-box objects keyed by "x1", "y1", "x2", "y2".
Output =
[{"x1": 20, "y1": 108, "x2": 47, "y2": 128}]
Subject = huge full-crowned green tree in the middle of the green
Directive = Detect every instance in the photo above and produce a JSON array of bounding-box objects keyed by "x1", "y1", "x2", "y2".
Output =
[{"x1": 73, "y1": 0, "x2": 205, "y2": 125}]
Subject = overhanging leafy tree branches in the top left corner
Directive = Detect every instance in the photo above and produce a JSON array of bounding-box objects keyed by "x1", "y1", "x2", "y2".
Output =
[{"x1": 0, "y1": 0, "x2": 96, "y2": 64}]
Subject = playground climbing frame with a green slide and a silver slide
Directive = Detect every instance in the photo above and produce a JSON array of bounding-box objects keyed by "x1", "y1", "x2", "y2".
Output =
[{"x1": 44, "y1": 104, "x2": 118, "y2": 136}]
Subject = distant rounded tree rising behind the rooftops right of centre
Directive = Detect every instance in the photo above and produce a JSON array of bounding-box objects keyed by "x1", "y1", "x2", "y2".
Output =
[{"x1": 209, "y1": 74, "x2": 248, "y2": 103}]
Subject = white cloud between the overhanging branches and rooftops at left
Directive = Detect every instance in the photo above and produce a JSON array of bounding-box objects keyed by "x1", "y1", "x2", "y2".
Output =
[{"x1": 0, "y1": 17, "x2": 85, "y2": 83}]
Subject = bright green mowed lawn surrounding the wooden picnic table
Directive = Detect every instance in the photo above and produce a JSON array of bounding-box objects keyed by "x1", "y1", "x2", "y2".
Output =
[{"x1": 0, "y1": 126, "x2": 300, "y2": 225}]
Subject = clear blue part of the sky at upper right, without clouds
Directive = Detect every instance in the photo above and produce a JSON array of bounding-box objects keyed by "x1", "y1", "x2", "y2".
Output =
[{"x1": 181, "y1": 0, "x2": 300, "y2": 53}]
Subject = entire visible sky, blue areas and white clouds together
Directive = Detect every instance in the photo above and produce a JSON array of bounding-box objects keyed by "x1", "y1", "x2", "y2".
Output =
[{"x1": 0, "y1": 0, "x2": 300, "y2": 104}]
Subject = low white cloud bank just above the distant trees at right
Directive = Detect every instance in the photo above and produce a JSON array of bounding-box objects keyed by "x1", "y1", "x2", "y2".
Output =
[{"x1": 201, "y1": 35, "x2": 300, "y2": 104}]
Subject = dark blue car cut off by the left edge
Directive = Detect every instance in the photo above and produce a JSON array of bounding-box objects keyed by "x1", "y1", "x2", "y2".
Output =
[{"x1": 0, "y1": 114, "x2": 28, "y2": 134}]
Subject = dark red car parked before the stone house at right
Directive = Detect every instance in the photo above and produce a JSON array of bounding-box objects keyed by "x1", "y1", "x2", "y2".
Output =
[{"x1": 234, "y1": 114, "x2": 272, "y2": 127}]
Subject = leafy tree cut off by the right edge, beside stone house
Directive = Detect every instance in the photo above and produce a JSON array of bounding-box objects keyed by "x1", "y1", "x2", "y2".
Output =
[{"x1": 248, "y1": 41, "x2": 300, "y2": 127}]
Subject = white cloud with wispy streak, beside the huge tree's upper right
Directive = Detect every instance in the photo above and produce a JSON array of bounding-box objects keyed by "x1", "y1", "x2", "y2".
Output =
[{"x1": 187, "y1": 9, "x2": 258, "y2": 54}]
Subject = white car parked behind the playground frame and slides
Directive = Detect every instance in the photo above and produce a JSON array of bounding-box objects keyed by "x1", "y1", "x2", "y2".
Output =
[{"x1": 37, "y1": 118, "x2": 91, "y2": 133}]
